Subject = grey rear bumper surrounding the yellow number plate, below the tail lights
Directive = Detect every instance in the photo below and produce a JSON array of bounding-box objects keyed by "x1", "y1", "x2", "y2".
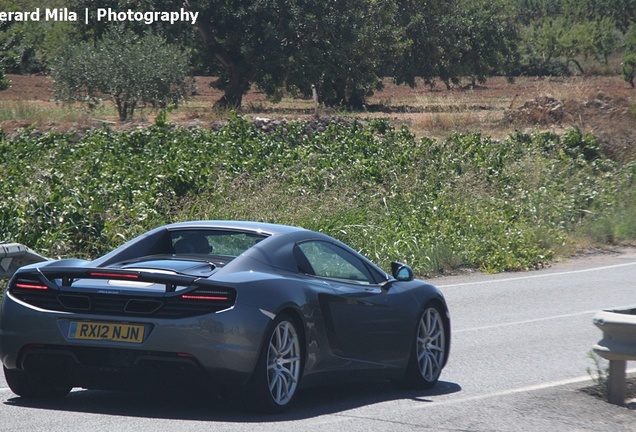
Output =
[{"x1": 0, "y1": 294, "x2": 271, "y2": 389}]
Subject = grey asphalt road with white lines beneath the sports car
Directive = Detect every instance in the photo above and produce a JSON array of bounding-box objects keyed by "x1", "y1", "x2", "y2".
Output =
[{"x1": 0, "y1": 249, "x2": 636, "y2": 432}]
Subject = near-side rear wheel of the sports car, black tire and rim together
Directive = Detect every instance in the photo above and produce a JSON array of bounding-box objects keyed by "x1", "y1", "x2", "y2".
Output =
[{"x1": 244, "y1": 313, "x2": 303, "y2": 414}]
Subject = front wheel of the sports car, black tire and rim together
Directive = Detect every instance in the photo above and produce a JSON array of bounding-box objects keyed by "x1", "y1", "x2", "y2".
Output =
[{"x1": 398, "y1": 303, "x2": 449, "y2": 389}]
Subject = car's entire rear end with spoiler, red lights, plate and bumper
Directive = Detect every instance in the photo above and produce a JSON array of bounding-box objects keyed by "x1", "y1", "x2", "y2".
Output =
[{"x1": 0, "y1": 265, "x2": 268, "y2": 391}]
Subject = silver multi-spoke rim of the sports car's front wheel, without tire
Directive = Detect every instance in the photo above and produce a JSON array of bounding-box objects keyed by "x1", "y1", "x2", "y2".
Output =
[{"x1": 417, "y1": 308, "x2": 446, "y2": 382}]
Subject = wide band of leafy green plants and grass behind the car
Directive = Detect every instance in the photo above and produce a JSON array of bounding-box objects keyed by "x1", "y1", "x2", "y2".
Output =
[{"x1": 0, "y1": 116, "x2": 636, "y2": 273}]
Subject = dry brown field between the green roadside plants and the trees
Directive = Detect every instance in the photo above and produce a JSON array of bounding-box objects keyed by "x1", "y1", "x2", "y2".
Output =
[{"x1": 0, "y1": 75, "x2": 636, "y2": 157}]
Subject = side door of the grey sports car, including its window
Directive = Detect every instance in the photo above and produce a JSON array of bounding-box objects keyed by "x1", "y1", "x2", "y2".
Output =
[{"x1": 295, "y1": 240, "x2": 409, "y2": 363}]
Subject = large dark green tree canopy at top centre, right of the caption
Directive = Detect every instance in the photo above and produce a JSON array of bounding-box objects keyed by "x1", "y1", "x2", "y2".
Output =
[{"x1": 191, "y1": 0, "x2": 401, "y2": 109}]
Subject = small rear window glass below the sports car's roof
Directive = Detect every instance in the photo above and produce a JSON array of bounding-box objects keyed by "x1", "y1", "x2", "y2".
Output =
[{"x1": 170, "y1": 230, "x2": 267, "y2": 258}]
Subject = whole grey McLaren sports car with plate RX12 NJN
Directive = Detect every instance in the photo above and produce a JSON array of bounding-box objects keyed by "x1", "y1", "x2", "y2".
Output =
[{"x1": 0, "y1": 221, "x2": 450, "y2": 412}]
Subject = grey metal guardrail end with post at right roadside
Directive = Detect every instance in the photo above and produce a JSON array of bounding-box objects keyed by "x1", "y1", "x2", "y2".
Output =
[{"x1": 593, "y1": 308, "x2": 636, "y2": 405}]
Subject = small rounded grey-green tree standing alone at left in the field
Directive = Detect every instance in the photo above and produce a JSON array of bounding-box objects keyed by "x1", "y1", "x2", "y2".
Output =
[{"x1": 51, "y1": 31, "x2": 194, "y2": 121}]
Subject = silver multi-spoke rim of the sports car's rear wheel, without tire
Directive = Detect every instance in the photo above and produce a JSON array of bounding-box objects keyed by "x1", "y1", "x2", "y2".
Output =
[{"x1": 267, "y1": 321, "x2": 300, "y2": 405}]
